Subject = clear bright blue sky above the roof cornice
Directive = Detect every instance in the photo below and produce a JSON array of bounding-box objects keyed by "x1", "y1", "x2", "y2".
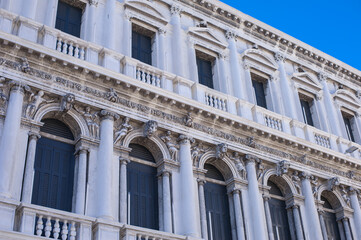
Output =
[{"x1": 221, "y1": 0, "x2": 361, "y2": 70}]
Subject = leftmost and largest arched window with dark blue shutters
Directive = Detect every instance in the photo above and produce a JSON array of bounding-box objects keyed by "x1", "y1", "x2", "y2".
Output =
[{"x1": 31, "y1": 119, "x2": 75, "y2": 211}]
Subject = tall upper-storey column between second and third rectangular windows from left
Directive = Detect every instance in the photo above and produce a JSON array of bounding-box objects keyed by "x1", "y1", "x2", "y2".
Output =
[{"x1": 170, "y1": 4, "x2": 186, "y2": 77}]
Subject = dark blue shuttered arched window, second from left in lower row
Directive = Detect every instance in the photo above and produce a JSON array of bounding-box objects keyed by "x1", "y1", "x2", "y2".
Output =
[{"x1": 127, "y1": 143, "x2": 159, "y2": 229}]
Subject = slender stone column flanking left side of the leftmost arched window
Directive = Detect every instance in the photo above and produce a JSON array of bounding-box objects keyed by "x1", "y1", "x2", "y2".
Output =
[{"x1": 21, "y1": 132, "x2": 40, "y2": 203}]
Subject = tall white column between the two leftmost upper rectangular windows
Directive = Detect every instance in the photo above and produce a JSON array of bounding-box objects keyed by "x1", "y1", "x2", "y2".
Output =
[{"x1": 103, "y1": 0, "x2": 116, "y2": 49}]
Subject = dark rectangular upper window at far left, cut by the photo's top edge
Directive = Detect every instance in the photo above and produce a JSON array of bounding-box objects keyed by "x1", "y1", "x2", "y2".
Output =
[{"x1": 55, "y1": 1, "x2": 82, "y2": 37}]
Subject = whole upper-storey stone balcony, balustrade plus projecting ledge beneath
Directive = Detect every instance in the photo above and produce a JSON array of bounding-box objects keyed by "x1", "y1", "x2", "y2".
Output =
[{"x1": 0, "y1": 9, "x2": 361, "y2": 166}]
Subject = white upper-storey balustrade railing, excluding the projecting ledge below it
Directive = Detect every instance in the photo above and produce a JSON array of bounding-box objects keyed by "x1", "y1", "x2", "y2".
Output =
[{"x1": 0, "y1": 9, "x2": 361, "y2": 158}]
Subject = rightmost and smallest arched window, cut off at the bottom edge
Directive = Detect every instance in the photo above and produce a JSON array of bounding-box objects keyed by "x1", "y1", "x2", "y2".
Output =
[{"x1": 321, "y1": 195, "x2": 341, "y2": 240}]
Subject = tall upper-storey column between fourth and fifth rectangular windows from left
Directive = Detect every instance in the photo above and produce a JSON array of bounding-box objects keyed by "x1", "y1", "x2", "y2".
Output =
[{"x1": 274, "y1": 52, "x2": 297, "y2": 119}]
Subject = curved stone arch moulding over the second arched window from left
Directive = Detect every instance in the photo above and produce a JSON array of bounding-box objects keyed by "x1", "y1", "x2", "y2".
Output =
[{"x1": 123, "y1": 128, "x2": 171, "y2": 162}]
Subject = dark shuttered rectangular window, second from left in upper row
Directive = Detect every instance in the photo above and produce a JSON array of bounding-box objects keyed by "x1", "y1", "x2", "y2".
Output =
[{"x1": 132, "y1": 30, "x2": 152, "y2": 65}]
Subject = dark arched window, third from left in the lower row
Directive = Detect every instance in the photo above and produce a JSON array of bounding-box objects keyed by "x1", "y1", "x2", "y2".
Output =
[{"x1": 204, "y1": 164, "x2": 232, "y2": 240}]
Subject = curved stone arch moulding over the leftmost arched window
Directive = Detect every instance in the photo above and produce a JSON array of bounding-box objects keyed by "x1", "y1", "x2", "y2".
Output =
[{"x1": 34, "y1": 103, "x2": 90, "y2": 138}]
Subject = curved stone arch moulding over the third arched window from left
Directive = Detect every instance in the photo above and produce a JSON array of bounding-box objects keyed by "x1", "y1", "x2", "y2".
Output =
[{"x1": 198, "y1": 151, "x2": 240, "y2": 181}]
